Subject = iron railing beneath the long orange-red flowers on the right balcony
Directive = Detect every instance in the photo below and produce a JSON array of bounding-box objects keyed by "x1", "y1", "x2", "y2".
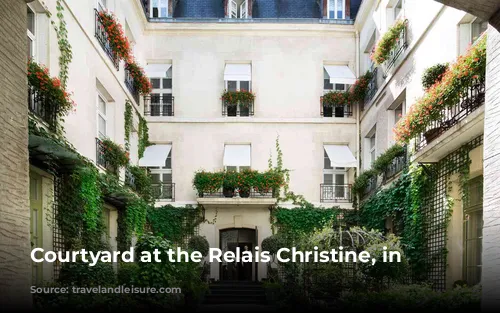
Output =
[{"x1": 415, "y1": 79, "x2": 485, "y2": 151}]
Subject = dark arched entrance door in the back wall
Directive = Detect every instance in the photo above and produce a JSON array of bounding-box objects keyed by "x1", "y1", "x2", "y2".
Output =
[{"x1": 219, "y1": 228, "x2": 256, "y2": 281}]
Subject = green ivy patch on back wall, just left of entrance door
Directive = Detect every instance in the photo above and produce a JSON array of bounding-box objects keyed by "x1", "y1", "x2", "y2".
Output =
[{"x1": 147, "y1": 205, "x2": 203, "y2": 243}]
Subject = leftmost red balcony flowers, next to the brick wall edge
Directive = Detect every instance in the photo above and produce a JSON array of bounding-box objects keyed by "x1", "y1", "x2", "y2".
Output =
[{"x1": 28, "y1": 60, "x2": 75, "y2": 116}]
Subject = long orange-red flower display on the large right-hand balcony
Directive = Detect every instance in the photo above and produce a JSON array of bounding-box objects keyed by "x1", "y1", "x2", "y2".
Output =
[{"x1": 394, "y1": 36, "x2": 486, "y2": 143}]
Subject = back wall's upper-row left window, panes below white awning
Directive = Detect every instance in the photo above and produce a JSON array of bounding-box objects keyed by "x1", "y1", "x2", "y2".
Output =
[{"x1": 149, "y1": 67, "x2": 174, "y2": 116}]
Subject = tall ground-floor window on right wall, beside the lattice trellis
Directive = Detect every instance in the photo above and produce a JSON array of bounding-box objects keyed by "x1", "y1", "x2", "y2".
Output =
[{"x1": 464, "y1": 176, "x2": 483, "y2": 286}]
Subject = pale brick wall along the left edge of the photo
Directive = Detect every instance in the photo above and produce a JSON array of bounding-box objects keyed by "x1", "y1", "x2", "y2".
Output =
[{"x1": 0, "y1": 0, "x2": 31, "y2": 309}]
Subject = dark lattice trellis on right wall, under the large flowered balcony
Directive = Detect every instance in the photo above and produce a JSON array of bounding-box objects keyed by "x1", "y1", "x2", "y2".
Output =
[{"x1": 422, "y1": 135, "x2": 483, "y2": 290}]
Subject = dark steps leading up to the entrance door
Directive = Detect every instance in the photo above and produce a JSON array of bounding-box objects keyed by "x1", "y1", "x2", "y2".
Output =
[{"x1": 205, "y1": 281, "x2": 267, "y2": 305}]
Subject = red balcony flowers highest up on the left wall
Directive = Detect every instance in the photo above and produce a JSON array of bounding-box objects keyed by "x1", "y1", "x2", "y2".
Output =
[{"x1": 99, "y1": 11, "x2": 132, "y2": 62}]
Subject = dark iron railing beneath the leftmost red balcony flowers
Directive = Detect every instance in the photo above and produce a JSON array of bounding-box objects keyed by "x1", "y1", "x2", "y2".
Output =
[{"x1": 28, "y1": 86, "x2": 58, "y2": 130}]
